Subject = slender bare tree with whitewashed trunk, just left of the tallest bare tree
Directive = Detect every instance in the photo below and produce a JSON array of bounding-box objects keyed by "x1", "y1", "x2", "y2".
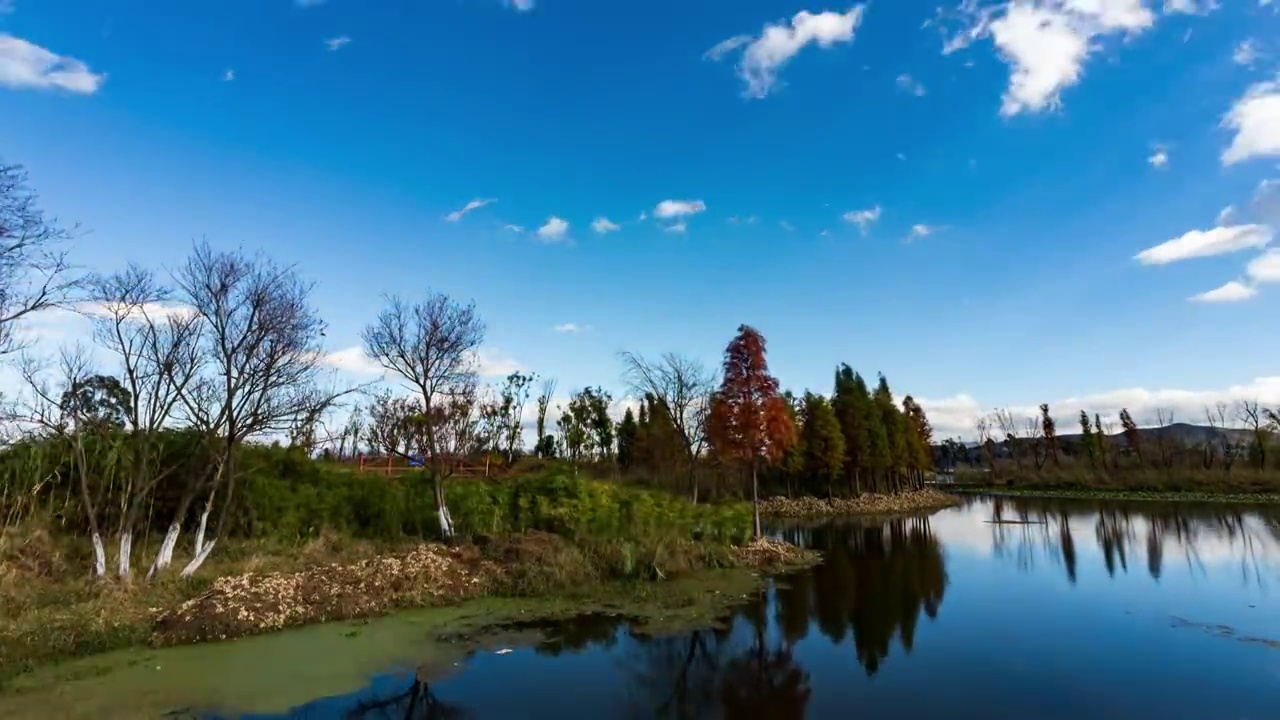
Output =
[{"x1": 88, "y1": 265, "x2": 201, "y2": 580}]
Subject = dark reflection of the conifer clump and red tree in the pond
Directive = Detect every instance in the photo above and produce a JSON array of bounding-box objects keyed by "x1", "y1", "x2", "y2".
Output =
[{"x1": 625, "y1": 518, "x2": 947, "y2": 719}]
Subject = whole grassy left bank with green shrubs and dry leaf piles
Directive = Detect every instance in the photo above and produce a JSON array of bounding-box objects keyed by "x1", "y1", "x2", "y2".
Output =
[{"x1": 0, "y1": 475, "x2": 812, "y2": 685}]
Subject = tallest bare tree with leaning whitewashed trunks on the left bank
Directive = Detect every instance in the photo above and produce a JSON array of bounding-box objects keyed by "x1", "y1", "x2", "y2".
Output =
[{"x1": 165, "y1": 242, "x2": 351, "y2": 575}]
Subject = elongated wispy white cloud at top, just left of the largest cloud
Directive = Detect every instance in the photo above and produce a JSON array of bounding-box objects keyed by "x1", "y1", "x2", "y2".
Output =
[{"x1": 704, "y1": 5, "x2": 864, "y2": 100}]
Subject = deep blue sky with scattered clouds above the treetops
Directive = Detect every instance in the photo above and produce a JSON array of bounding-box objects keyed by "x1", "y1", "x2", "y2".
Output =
[{"x1": 0, "y1": 0, "x2": 1280, "y2": 432}]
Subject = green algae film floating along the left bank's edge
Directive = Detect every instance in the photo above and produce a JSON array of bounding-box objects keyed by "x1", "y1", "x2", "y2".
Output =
[{"x1": 0, "y1": 570, "x2": 760, "y2": 720}]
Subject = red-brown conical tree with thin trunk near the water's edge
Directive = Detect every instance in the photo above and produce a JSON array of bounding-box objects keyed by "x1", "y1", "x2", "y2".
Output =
[{"x1": 707, "y1": 325, "x2": 796, "y2": 537}]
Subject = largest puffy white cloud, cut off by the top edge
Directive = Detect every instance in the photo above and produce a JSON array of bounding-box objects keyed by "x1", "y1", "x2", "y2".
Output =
[{"x1": 942, "y1": 0, "x2": 1156, "y2": 115}]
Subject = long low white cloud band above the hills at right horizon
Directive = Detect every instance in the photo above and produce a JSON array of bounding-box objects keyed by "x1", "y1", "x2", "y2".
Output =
[{"x1": 916, "y1": 375, "x2": 1280, "y2": 439}]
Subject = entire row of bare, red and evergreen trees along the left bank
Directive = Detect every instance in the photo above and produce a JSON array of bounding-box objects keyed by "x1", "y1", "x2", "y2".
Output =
[{"x1": 0, "y1": 156, "x2": 929, "y2": 579}]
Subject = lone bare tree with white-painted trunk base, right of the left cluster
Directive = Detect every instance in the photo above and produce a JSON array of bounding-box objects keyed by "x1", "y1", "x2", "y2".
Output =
[{"x1": 362, "y1": 292, "x2": 485, "y2": 538}]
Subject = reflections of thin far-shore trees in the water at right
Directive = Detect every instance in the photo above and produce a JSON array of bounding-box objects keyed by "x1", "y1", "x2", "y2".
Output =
[{"x1": 970, "y1": 497, "x2": 1280, "y2": 584}]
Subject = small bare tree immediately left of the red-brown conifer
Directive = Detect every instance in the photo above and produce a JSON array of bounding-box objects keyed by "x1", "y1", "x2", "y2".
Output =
[{"x1": 622, "y1": 352, "x2": 716, "y2": 503}]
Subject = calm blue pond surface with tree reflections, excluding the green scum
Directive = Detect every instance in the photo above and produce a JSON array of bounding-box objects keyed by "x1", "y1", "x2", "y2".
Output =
[{"x1": 204, "y1": 498, "x2": 1280, "y2": 720}]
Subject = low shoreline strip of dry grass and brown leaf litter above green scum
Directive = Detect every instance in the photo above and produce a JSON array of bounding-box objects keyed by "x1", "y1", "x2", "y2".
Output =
[{"x1": 0, "y1": 533, "x2": 820, "y2": 686}]
